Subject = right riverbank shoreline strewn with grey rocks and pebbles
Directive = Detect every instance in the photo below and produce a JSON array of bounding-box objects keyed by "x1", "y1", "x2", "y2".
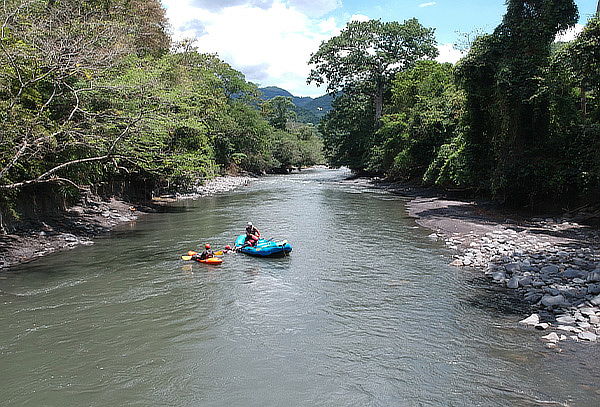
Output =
[{"x1": 368, "y1": 180, "x2": 600, "y2": 351}]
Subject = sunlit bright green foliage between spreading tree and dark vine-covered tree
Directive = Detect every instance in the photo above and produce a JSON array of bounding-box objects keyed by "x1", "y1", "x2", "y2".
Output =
[{"x1": 370, "y1": 61, "x2": 464, "y2": 179}]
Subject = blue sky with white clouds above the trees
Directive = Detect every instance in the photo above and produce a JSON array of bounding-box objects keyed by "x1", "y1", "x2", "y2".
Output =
[{"x1": 161, "y1": 0, "x2": 597, "y2": 97}]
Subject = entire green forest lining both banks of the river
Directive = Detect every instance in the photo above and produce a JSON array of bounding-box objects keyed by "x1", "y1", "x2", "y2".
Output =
[{"x1": 0, "y1": 0, "x2": 600, "y2": 230}]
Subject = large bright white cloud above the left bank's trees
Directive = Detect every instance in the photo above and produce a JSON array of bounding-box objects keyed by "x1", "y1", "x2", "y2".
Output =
[{"x1": 163, "y1": 0, "x2": 341, "y2": 96}]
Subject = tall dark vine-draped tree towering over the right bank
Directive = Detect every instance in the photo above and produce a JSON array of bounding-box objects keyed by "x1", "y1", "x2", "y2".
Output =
[{"x1": 457, "y1": 0, "x2": 577, "y2": 205}]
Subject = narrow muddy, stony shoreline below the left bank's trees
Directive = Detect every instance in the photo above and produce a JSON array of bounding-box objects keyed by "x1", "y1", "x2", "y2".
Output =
[{"x1": 0, "y1": 176, "x2": 255, "y2": 274}]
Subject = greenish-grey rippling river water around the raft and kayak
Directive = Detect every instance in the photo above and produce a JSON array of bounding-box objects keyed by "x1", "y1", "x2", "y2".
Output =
[{"x1": 0, "y1": 169, "x2": 600, "y2": 406}]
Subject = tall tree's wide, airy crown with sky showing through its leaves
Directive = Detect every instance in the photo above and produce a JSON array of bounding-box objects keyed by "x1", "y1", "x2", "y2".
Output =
[{"x1": 308, "y1": 18, "x2": 438, "y2": 121}]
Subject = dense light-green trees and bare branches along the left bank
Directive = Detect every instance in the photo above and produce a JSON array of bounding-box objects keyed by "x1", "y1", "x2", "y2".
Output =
[{"x1": 0, "y1": 0, "x2": 322, "y2": 223}]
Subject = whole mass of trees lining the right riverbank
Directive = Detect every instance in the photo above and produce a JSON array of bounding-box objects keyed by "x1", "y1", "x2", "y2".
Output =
[{"x1": 309, "y1": 0, "x2": 600, "y2": 207}]
